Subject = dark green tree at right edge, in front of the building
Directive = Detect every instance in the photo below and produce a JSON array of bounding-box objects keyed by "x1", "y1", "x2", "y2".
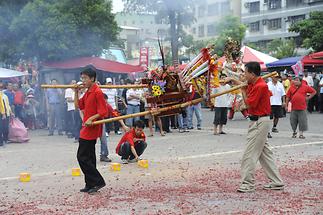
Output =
[{"x1": 289, "y1": 11, "x2": 323, "y2": 51}]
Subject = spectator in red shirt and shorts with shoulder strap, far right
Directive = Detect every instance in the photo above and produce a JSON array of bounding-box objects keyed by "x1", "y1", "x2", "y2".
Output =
[{"x1": 285, "y1": 77, "x2": 316, "y2": 139}]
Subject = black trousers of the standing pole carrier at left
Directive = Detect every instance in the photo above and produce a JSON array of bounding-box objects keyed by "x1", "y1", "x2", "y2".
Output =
[{"x1": 77, "y1": 138, "x2": 105, "y2": 188}]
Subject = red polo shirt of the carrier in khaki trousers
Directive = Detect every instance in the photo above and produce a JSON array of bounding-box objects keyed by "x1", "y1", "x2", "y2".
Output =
[{"x1": 246, "y1": 78, "x2": 272, "y2": 116}]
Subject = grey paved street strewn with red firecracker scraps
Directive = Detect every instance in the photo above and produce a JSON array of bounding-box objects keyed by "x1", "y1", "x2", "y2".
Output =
[{"x1": 0, "y1": 109, "x2": 323, "y2": 214}]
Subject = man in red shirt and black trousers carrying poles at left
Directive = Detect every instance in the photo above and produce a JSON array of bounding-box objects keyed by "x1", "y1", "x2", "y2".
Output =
[{"x1": 74, "y1": 68, "x2": 108, "y2": 193}]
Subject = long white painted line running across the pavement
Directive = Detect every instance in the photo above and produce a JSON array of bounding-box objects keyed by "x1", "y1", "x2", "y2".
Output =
[{"x1": 0, "y1": 141, "x2": 323, "y2": 181}]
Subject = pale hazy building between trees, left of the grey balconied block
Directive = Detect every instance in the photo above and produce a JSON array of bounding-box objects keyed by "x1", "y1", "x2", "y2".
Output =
[{"x1": 188, "y1": 0, "x2": 241, "y2": 40}]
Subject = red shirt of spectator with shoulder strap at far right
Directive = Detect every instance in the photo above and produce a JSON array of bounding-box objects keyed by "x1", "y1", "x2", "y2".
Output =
[{"x1": 286, "y1": 82, "x2": 316, "y2": 110}]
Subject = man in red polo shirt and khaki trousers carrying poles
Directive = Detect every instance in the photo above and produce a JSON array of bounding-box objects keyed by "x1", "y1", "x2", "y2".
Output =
[{"x1": 227, "y1": 62, "x2": 284, "y2": 193}]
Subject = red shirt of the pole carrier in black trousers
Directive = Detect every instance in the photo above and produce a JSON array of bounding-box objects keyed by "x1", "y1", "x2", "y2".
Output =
[{"x1": 78, "y1": 84, "x2": 108, "y2": 140}]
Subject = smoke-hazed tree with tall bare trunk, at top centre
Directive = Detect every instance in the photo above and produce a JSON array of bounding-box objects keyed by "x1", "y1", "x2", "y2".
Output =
[{"x1": 123, "y1": 0, "x2": 194, "y2": 65}]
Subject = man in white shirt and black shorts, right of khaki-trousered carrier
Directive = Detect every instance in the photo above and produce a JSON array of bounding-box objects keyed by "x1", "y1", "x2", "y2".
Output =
[{"x1": 268, "y1": 76, "x2": 286, "y2": 138}]
